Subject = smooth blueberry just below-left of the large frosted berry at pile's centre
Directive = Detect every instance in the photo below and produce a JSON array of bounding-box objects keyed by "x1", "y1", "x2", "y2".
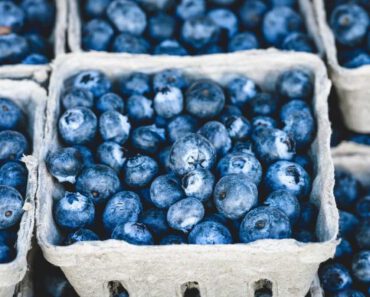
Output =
[{"x1": 150, "y1": 174, "x2": 185, "y2": 208}]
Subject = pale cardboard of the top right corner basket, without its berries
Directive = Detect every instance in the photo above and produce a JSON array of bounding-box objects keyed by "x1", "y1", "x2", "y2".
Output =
[{"x1": 313, "y1": 0, "x2": 370, "y2": 133}]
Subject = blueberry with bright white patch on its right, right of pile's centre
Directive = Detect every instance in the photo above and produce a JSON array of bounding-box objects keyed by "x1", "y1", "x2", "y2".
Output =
[{"x1": 252, "y1": 127, "x2": 295, "y2": 164}]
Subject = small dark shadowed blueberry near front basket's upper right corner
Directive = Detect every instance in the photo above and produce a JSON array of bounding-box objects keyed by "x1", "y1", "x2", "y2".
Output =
[{"x1": 248, "y1": 92, "x2": 278, "y2": 117}]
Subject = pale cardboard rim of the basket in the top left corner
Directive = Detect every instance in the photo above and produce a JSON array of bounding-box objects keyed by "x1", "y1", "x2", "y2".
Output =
[{"x1": 0, "y1": 0, "x2": 68, "y2": 83}]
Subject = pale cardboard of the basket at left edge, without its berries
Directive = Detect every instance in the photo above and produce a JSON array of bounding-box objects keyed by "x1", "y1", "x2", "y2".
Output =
[{"x1": 0, "y1": 80, "x2": 47, "y2": 297}]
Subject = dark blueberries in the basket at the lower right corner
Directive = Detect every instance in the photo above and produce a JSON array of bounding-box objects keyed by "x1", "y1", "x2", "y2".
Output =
[{"x1": 319, "y1": 168, "x2": 370, "y2": 297}]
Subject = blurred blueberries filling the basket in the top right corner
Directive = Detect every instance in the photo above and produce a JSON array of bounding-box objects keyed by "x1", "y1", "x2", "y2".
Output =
[{"x1": 325, "y1": 0, "x2": 370, "y2": 68}]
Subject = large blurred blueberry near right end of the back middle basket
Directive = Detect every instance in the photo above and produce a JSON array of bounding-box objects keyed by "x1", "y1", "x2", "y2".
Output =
[{"x1": 262, "y1": 6, "x2": 303, "y2": 47}]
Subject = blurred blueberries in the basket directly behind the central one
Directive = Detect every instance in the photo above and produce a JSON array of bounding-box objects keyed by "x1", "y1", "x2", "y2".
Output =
[{"x1": 80, "y1": 0, "x2": 316, "y2": 56}]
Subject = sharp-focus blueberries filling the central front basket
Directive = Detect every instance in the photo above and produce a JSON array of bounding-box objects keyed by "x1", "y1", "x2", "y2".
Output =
[{"x1": 45, "y1": 68, "x2": 318, "y2": 245}]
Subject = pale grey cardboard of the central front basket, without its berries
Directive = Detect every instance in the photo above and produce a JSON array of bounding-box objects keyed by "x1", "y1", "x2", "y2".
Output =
[{"x1": 37, "y1": 51, "x2": 338, "y2": 297}]
